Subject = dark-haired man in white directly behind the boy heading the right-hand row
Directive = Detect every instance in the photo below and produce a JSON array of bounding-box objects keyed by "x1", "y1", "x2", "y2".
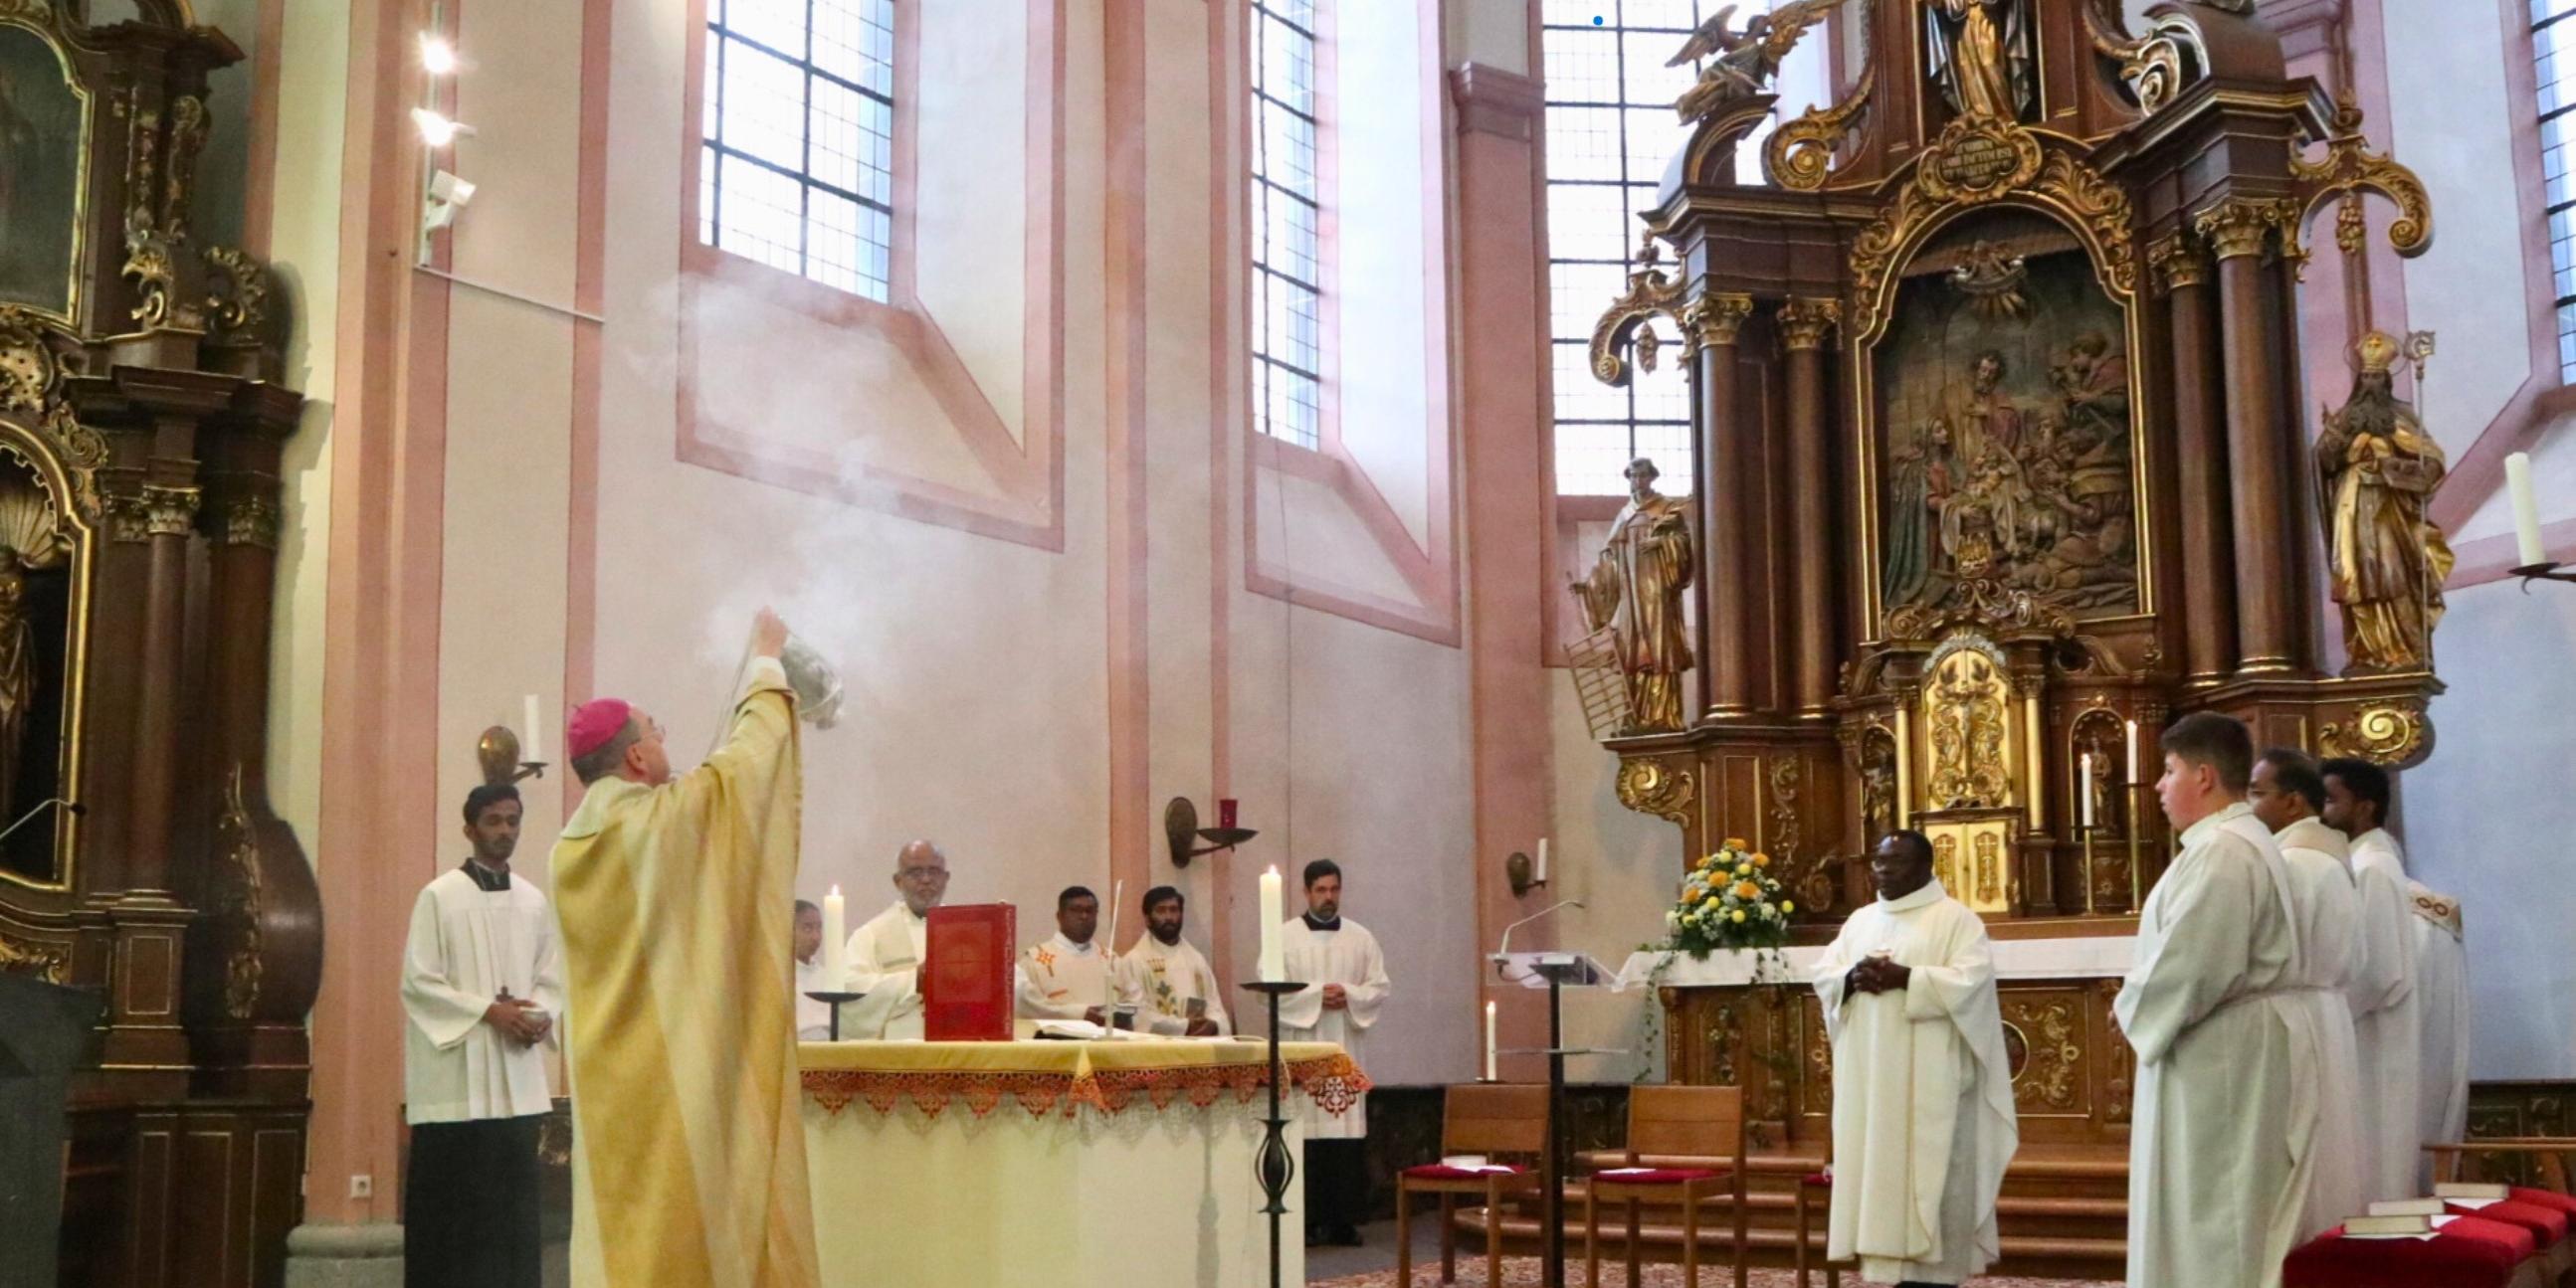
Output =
[{"x1": 2247, "y1": 747, "x2": 2370, "y2": 1241}]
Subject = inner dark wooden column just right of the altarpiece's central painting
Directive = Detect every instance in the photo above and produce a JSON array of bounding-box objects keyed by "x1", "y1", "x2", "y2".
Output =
[{"x1": 2153, "y1": 232, "x2": 2236, "y2": 682}]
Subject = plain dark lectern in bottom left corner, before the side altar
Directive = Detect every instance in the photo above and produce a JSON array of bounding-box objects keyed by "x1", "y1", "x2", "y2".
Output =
[{"x1": 0, "y1": 974, "x2": 105, "y2": 1288}]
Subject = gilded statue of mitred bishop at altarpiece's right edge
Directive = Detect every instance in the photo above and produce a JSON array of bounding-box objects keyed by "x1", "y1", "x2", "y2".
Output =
[{"x1": 2316, "y1": 332, "x2": 2453, "y2": 669}]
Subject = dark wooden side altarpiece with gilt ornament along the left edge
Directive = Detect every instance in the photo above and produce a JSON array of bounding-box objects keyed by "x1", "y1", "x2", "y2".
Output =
[{"x1": 0, "y1": 0, "x2": 322, "y2": 1285}]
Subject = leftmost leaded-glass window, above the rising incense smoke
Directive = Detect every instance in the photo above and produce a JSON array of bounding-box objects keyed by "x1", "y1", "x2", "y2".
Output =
[{"x1": 698, "y1": 0, "x2": 896, "y2": 301}]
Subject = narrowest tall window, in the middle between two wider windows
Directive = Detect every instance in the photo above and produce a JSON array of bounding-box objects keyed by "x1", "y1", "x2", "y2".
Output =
[{"x1": 1252, "y1": 0, "x2": 1318, "y2": 449}]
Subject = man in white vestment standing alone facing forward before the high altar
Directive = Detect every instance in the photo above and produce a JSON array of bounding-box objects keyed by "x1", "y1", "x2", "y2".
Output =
[{"x1": 1816, "y1": 832, "x2": 2022, "y2": 1285}]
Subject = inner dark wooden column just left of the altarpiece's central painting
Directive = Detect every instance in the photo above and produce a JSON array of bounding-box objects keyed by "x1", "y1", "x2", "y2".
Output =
[{"x1": 1780, "y1": 298, "x2": 1842, "y2": 719}]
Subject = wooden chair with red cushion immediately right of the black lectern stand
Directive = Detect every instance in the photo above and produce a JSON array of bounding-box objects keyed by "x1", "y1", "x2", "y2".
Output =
[{"x1": 1584, "y1": 1087, "x2": 1746, "y2": 1288}]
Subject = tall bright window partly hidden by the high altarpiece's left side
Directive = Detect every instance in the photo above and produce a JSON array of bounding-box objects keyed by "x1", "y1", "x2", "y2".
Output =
[{"x1": 1540, "y1": 0, "x2": 1761, "y2": 494}]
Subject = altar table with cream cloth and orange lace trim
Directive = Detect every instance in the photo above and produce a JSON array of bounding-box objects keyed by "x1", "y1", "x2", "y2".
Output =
[{"x1": 799, "y1": 1040, "x2": 1368, "y2": 1288}]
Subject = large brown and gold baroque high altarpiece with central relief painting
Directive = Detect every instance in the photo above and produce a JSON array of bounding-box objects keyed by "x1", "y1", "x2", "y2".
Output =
[{"x1": 1592, "y1": 0, "x2": 2448, "y2": 1180}]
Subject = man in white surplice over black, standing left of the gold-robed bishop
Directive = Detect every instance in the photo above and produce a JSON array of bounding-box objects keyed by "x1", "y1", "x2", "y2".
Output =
[{"x1": 402, "y1": 783, "x2": 564, "y2": 1288}]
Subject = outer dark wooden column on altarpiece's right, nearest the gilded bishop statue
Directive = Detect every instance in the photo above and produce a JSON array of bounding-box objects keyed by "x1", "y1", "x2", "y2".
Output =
[{"x1": 2200, "y1": 198, "x2": 2297, "y2": 675}]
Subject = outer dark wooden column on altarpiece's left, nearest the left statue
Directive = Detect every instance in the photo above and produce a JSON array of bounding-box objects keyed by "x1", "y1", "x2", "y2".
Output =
[{"x1": 1683, "y1": 293, "x2": 1759, "y2": 719}]
